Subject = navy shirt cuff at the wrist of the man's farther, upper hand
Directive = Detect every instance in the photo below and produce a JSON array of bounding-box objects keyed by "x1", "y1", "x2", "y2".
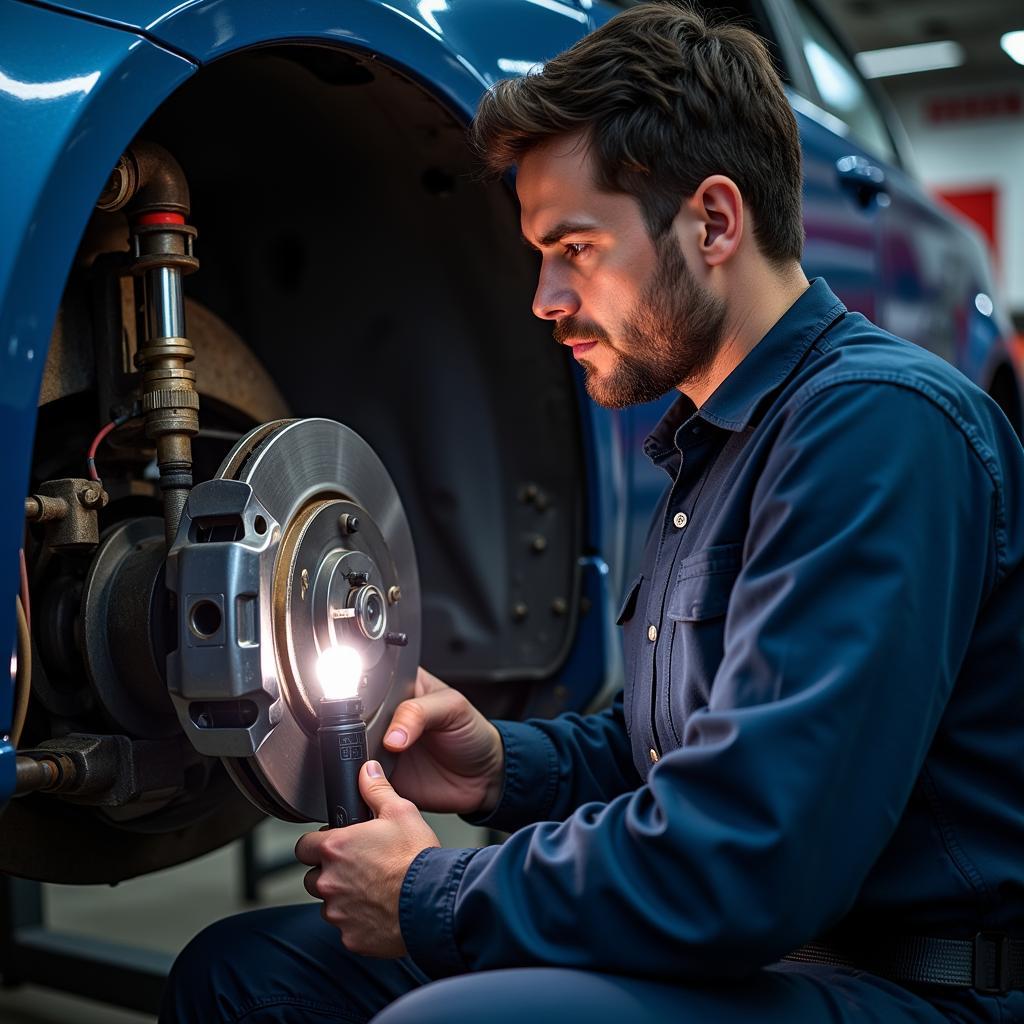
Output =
[{"x1": 461, "y1": 721, "x2": 559, "y2": 831}]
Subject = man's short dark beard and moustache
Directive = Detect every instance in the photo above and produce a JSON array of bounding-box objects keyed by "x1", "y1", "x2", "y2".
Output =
[{"x1": 554, "y1": 233, "x2": 726, "y2": 409}]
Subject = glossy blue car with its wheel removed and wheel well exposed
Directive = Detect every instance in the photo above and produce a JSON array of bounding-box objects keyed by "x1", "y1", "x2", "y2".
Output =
[{"x1": 0, "y1": 0, "x2": 1022, "y2": 1007}]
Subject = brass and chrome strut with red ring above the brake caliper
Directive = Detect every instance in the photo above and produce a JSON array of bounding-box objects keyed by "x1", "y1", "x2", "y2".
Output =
[{"x1": 97, "y1": 142, "x2": 199, "y2": 547}]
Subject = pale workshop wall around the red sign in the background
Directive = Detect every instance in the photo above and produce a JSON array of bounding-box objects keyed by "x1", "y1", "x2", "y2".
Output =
[{"x1": 887, "y1": 80, "x2": 1024, "y2": 315}]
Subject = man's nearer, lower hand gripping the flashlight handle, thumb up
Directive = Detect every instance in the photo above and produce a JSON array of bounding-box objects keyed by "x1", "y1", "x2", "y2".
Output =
[{"x1": 295, "y1": 761, "x2": 440, "y2": 956}]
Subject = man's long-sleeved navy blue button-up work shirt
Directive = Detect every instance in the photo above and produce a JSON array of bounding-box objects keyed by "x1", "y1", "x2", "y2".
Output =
[{"x1": 399, "y1": 280, "x2": 1024, "y2": 981}]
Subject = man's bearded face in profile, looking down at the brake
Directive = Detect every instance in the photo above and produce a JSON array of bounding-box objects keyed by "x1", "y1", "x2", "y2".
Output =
[{"x1": 516, "y1": 137, "x2": 725, "y2": 409}]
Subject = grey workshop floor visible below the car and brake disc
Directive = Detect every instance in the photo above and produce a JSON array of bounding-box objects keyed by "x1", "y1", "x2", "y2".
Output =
[{"x1": 0, "y1": 815, "x2": 484, "y2": 1024}]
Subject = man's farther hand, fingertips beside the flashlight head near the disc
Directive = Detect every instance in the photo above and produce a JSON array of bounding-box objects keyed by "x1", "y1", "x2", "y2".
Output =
[{"x1": 384, "y1": 669, "x2": 505, "y2": 814}]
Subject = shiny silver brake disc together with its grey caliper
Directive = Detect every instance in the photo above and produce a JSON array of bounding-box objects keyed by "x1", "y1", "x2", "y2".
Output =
[{"x1": 167, "y1": 419, "x2": 420, "y2": 821}]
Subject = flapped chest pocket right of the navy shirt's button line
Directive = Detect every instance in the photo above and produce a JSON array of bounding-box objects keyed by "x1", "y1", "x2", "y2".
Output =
[{"x1": 656, "y1": 544, "x2": 742, "y2": 744}]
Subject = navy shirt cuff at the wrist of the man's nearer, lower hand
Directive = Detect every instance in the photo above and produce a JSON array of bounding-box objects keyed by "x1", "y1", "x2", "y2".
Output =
[{"x1": 398, "y1": 847, "x2": 479, "y2": 979}]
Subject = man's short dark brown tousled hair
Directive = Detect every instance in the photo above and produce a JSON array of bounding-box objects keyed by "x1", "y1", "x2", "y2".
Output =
[{"x1": 472, "y1": 0, "x2": 804, "y2": 264}]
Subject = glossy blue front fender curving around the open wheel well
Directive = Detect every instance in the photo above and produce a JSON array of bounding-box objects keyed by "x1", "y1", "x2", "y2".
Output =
[{"x1": 0, "y1": 0, "x2": 612, "y2": 801}]
